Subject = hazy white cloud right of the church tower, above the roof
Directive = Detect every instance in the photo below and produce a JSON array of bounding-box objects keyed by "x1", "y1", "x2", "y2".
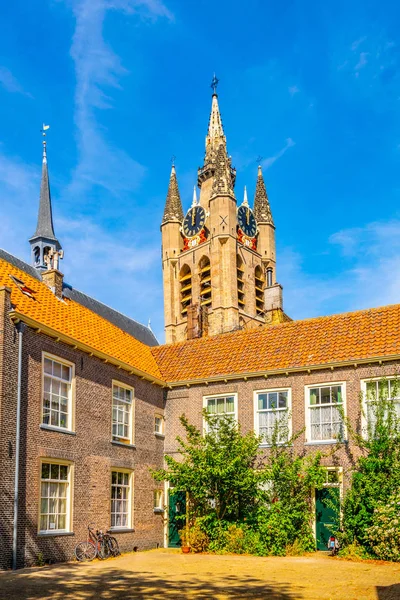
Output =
[{"x1": 277, "y1": 220, "x2": 400, "y2": 318}]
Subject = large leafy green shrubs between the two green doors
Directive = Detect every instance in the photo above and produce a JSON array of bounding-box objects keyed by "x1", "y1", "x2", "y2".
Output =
[{"x1": 153, "y1": 412, "x2": 325, "y2": 555}]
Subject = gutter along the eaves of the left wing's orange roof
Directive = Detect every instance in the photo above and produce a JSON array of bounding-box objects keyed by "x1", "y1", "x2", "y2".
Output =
[{"x1": 9, "y1": 310, "x2": 166, "y2": 387}]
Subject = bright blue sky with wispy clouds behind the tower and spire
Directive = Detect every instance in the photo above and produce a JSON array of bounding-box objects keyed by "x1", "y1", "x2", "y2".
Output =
[{"x1": 0, "y1": 0, "x2": 400, "y2": 340}]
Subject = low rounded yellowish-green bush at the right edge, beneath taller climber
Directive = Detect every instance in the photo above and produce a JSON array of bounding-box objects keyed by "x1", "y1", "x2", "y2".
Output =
[{"x1": 366, "y1": 491, "x2": 400, "y2": 561}]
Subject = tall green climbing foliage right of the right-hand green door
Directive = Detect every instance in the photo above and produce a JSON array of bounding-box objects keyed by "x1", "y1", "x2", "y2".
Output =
[{"x1": 339, "y1": 379, "x2": 400, "y2": 556}]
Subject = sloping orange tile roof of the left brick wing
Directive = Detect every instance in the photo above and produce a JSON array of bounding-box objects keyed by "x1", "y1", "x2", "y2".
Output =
[{"x1": 0, "y1": 259, "x2": 161, "y2": 379}]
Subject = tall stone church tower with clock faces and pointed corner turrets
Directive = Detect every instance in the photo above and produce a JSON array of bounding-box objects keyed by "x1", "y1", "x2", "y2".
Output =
[{"x1": 161, "y1": 78, "x2": 289, "y2": 343}]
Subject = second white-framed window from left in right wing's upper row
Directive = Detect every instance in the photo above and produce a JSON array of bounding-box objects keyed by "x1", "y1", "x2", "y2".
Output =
[{"x1": 254, "y1": 388, "x2": 291, "y2": 445}]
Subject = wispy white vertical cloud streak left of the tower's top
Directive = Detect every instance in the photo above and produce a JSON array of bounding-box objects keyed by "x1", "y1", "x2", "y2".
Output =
[{"x1": 66, "y1": 0, "x2": 172, "y2": 194}]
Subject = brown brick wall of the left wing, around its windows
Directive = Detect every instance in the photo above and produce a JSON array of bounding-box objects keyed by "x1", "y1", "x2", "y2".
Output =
[{"x1": 0, "y1": 313, "x2": 164, "y2": 568}]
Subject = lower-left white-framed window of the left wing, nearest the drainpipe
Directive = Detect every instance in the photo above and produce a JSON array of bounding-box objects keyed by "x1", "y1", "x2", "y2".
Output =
[{"x1": 39, "y1": 459, "x2": 72, "y2": 533}]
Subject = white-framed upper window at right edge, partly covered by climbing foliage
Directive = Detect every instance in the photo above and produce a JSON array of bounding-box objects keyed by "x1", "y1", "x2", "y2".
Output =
[{"x1": 361, "y1": 377, "x2": 400, "y2": 435}]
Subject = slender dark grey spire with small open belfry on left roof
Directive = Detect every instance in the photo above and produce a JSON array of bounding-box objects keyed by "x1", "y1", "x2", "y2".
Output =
[{"x1": 29, "y1": 124, "x2": 61, "y2": 270}]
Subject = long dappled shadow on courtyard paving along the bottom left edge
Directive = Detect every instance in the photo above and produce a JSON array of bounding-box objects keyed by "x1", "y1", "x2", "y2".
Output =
[{"x1": 0, "y1": 566, "x2": 302, "y2": 600}]
